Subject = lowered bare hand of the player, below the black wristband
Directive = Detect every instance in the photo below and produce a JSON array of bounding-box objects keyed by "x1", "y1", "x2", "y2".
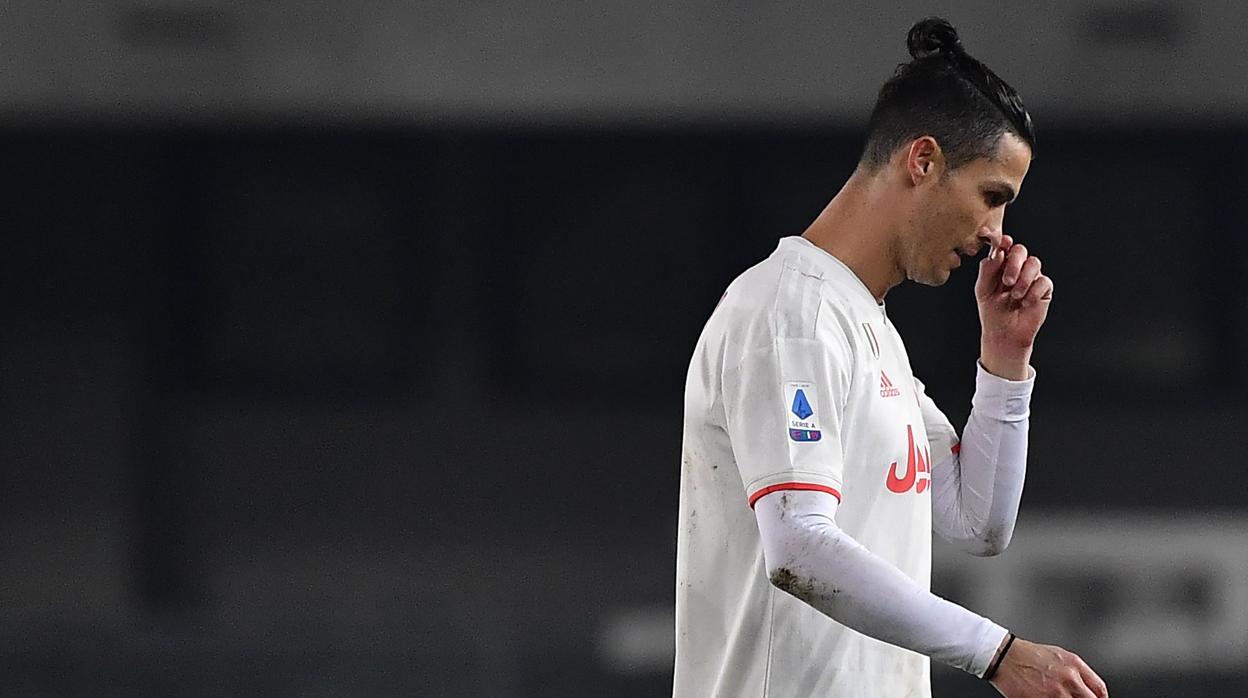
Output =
[{"x1": 990, "y1": 638, "x2": 1109, "y2": 698}]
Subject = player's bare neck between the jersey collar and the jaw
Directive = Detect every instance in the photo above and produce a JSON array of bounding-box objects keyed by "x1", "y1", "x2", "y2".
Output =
[{"x1": 801, "y1": 170, "x2": 906, "y2": 301}]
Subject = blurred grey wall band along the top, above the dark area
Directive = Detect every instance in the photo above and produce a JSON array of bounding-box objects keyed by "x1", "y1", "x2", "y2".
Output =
[{"x1": 0, "y1": 0, "x2": 1248, "y2": 124}]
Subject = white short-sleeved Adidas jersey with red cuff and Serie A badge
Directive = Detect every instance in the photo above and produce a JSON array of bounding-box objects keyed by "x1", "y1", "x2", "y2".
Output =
[{"x1": 674, "y1": 237, "x2": 957, "y2": 698}]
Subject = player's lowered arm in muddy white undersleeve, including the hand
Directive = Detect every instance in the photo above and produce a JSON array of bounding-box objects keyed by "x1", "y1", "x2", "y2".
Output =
[{"x1": 754, "y1": 491, "x2": 1108, "y2": 698}]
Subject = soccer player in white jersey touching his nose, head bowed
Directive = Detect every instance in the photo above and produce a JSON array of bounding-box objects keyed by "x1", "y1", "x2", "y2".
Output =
[{"x1": 674, "y1": 19, "x2": 1108, "y2": 698}]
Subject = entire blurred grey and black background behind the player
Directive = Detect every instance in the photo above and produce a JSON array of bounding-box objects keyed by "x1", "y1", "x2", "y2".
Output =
[{"x1": 0, "y1": 0, "x2": 1248, "y2": 698}]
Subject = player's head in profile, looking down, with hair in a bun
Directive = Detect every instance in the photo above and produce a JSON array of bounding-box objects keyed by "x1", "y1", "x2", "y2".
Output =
[{"x1": 859, "y1": 17, "x2": 1036, "y2": 285}]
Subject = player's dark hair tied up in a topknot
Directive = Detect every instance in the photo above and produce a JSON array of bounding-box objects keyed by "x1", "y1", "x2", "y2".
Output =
[{"x1": 861, "y1": 17, "x2": 1036, "y2": 170}]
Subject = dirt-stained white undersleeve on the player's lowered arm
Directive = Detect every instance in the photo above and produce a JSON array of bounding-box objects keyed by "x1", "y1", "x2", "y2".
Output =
[{"x1": 754, "y1": 491, "x2": 1006, "y2": 676}]
